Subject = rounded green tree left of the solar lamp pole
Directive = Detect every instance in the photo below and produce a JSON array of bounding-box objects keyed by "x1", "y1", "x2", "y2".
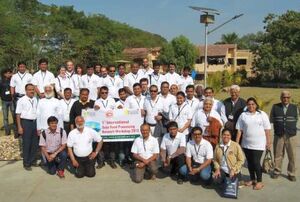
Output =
[{"x1": 158, "y1": 35, "x2": 197, "y2": 71}]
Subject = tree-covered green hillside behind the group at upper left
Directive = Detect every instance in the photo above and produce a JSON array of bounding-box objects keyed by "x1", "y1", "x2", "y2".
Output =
[{"x1": 0, "y1": 0, "x2": 166, "y2": 68}]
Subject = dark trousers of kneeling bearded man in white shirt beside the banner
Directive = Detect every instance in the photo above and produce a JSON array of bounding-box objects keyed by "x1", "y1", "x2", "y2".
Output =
[{"x1": 75, "y1": 156, "x2": 96, "y2": 178}]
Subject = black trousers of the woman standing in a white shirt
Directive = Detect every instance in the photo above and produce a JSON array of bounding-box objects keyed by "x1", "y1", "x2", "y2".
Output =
[{"x1": 243, "y1": 148, "x2": 263, "y2": 182}]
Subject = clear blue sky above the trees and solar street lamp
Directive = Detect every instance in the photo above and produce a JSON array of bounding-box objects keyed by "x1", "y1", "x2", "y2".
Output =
[{"x1": 39, "y1": 0, "x2": 300, "y2": 44}]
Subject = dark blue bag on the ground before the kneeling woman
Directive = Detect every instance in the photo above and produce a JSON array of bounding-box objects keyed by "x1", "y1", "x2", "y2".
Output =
[{"x1": 223, "y1": 177, "x2": 239, "y2": 199}]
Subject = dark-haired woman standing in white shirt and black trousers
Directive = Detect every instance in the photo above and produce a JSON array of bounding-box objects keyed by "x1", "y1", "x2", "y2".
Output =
[{"x1": 236, "y1": 97, "x2": 271, "y2": 190}]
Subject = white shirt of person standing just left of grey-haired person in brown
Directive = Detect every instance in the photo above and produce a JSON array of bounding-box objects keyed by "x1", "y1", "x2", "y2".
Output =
[{"x1": 169, "y1": 102, "x2": 193, "y2": 135}]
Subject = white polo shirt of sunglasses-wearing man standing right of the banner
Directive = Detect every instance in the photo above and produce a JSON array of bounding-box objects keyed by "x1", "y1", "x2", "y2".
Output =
[{"x1": 143, "y1": 96, "x2": 164, "y2": 124}]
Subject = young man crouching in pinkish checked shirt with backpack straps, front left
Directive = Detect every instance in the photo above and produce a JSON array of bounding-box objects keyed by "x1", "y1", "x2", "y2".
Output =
[{"x1": 39, "y1": 116, "x2": 67, "y2": 178}]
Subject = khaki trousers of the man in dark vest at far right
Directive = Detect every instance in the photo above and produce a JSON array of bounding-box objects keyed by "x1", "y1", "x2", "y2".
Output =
[{"x1": 273, "y1": 135, "x2": 297, "y2": 176}]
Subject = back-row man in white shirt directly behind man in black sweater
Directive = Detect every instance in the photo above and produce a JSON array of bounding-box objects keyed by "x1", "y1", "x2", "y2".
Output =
[{"x1": 81, "y1": 66, "x2": 103, "y2": 101}]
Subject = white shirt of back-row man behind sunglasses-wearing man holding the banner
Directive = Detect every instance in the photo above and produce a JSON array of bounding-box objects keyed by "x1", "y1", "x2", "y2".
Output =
[{"x1": 103, "y1": 75, "x2": 123, "y2": 98}]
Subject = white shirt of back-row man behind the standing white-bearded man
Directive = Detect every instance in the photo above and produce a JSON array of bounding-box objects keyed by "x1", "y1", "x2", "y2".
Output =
[{"x1": 32, "y1": 70, "x2": 55, "y2": 93}]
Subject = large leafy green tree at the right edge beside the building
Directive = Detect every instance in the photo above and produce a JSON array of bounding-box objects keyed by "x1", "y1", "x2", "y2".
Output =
[{"x1": 255, "y1": 11, "x2": 300, "y2": 82}]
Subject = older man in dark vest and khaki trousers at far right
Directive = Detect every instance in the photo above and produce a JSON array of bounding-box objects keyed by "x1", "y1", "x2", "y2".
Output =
[{"x1": 270, "y1": 91, "x2": 299, "y2": 182}]
